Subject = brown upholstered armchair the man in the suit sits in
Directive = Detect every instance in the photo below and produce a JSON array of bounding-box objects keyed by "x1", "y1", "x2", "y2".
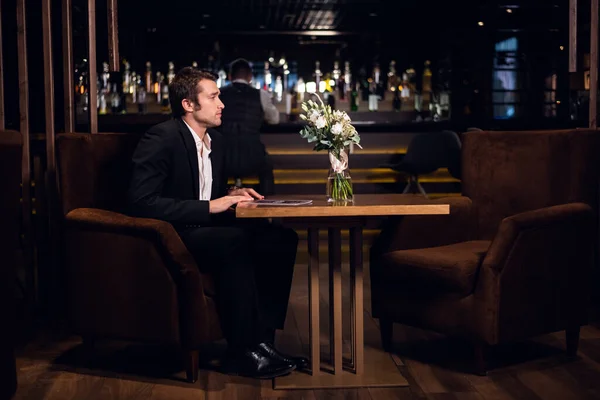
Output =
[{"x1": 57, "y1": 133, "x2": 222, "y2": 382}]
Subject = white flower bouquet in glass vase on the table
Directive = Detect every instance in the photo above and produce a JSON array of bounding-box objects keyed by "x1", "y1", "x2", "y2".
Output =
[{"x1": 300, "y1": 96, "x2": 362, "y2": 201}]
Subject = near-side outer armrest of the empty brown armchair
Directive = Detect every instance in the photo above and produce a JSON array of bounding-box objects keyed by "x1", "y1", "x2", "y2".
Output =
[{"x1": 475, "y1": 203, "x2": 596, "y2": 344}]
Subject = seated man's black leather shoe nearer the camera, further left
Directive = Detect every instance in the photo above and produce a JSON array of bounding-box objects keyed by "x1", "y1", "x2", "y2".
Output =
[{"x1": 228, "y1": 348, "x2": 296, "y2": 379}]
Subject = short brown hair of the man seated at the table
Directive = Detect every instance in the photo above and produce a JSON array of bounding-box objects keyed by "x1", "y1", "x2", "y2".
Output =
[{"x1": 169, "y1": 67, "x2": 216, "y2": 117}]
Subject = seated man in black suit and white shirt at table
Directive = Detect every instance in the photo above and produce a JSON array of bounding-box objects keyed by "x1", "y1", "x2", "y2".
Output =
[{"x1": 128, "y1": 67, "x2": 307, "y2": 378}]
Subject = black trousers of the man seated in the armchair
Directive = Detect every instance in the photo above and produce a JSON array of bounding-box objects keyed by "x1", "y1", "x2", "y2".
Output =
[{"x1": 180, "y1": 219, "x2": 298, "y2": 352}]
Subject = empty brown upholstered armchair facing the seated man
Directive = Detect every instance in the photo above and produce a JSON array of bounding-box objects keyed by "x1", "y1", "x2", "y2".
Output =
[{"x1": 370, "y1": 130, "x2": 600, "y2": 372}]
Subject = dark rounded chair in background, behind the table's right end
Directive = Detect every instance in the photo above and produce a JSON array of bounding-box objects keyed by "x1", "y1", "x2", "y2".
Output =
[{"x1": 381, "y1": 131, "x2": 461, "y2": 197}]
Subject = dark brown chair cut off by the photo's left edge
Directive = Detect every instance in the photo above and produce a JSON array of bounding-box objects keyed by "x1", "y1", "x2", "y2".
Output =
[{"x1": 0, "y1": 131, "x2": 23, "y2": 399}]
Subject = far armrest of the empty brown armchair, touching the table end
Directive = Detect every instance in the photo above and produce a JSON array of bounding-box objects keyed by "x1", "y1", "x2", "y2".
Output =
[{"x1": 371, "y1": 196, "x2": 474, "y2": 256}]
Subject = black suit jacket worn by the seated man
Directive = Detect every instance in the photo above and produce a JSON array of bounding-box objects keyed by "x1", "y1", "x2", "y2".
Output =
[{"x1": 127, "y1": 118, "x2": 227, "y2": 229}]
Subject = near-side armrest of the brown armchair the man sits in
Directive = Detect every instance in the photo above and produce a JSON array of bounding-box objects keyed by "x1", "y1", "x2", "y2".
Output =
[{"x1": 66, "y1": 208, "x2": 213, "y2": 347}]
